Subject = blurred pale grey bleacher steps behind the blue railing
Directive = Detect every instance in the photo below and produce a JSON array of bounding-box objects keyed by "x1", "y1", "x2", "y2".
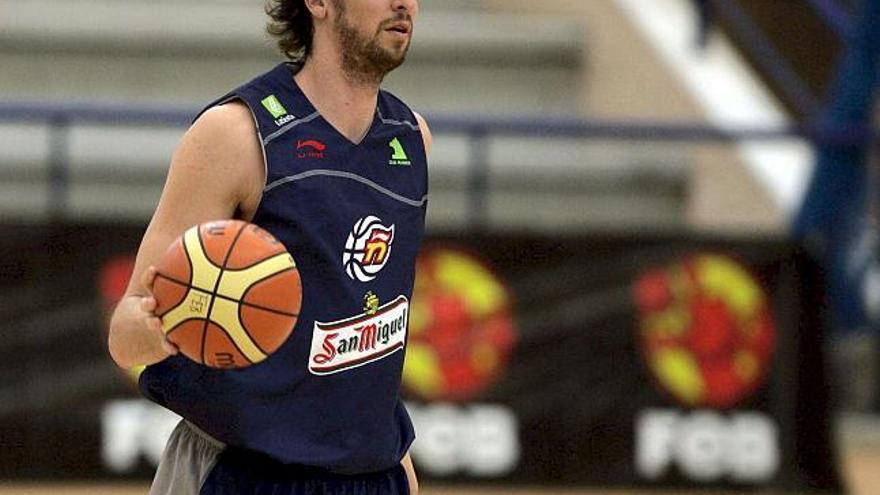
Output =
[{"x1": 0, "y1": 0, "x2": 690, "y2": 229}]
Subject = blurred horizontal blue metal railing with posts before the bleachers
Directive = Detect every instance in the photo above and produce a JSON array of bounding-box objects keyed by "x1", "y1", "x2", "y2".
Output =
[{"x1": 0, "y1": 102, "x2": 880, "y2": 228}]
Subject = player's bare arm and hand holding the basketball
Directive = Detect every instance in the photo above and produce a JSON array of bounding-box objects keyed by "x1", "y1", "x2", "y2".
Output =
[{"x1": 108, "y1": 102, "x2": 265, "y2": 368}]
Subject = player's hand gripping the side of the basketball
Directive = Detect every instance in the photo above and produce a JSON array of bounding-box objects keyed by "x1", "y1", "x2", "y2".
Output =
[{"x1": 108, "y1": 266, "x2": 178, "y2": 369}]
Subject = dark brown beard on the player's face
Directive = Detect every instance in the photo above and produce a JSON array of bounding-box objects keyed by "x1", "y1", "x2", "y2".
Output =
[{"x1": 334, "y1": 0, "x2": 409, "y2": 84}]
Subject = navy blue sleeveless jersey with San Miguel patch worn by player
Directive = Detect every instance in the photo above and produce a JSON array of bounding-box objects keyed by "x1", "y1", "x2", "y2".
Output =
[{"x1": 140, "y1": 64, "x2": 427, "y2": 474}]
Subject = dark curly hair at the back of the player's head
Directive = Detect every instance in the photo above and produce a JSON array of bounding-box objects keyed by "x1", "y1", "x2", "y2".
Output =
[{"x1": 266, "y1": 0, "x2": 315, "y2": 63}]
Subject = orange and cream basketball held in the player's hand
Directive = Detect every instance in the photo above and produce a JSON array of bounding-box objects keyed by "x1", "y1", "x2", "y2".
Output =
[{"x1": 153, "y1": 220, "x2": 302, "y2": 368}]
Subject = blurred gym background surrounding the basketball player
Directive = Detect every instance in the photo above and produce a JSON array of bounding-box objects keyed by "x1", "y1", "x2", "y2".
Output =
[{"x1": 0, "y1": 0, "x2": 880, "y2": 494}]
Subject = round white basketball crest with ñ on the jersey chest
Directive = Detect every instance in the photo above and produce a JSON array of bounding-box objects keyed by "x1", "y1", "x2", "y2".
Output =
[{"x1": 342, "y1": 215, "x2": 394, "y2": 282}]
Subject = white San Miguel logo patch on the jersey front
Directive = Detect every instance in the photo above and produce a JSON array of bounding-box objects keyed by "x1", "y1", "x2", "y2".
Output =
[{"x1": 309, "y1": 296, "x2": 409, "y2": 375}]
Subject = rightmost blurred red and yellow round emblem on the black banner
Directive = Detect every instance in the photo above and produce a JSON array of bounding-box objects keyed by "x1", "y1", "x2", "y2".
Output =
[{"x1": 634, "y1": 254, "x2": 776, "y2": 408}]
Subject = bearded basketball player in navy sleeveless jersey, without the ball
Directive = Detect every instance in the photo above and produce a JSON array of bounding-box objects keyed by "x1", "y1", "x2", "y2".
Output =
[{"x1": 108, "y1": 0, "x2": 431, "y2": 495}]
